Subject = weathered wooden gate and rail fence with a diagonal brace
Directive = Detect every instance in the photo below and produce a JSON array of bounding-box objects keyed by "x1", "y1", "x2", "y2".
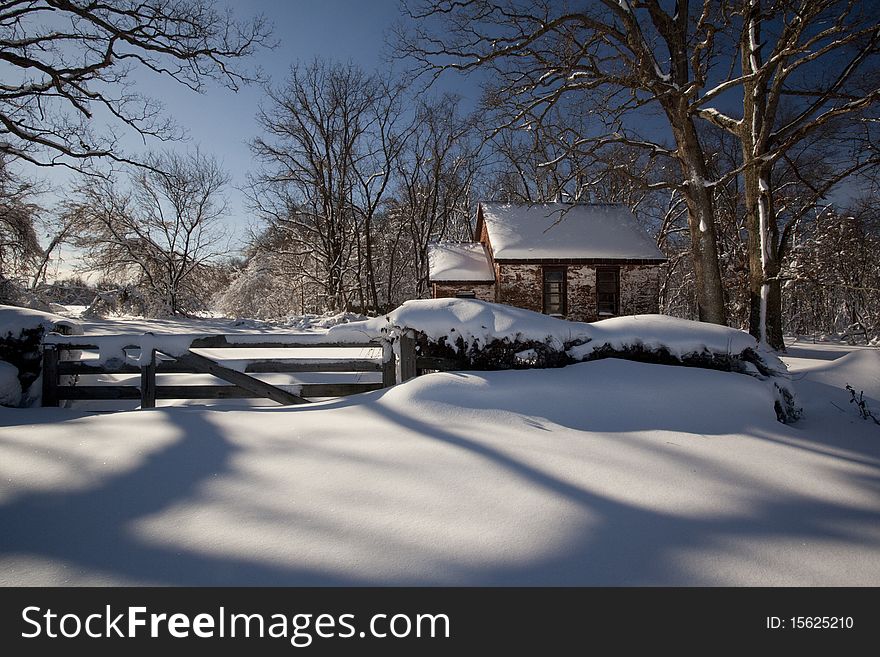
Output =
[{"x1": 42, "y1": 334, "x2": 398, "y2": 408}]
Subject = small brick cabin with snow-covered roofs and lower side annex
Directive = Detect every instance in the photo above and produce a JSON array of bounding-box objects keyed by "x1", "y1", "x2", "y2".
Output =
[{"x1": 428, "y1": 203, "x2": 666, "y2": 322}]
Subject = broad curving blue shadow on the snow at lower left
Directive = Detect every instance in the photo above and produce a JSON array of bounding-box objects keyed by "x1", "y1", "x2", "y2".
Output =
[{"x1": 0, "y1": 409, "x2": 368, "y2": 586}]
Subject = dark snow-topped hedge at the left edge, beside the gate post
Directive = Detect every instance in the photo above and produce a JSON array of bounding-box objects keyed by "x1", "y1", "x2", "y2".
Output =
[{"x1": 0, "y1": 306, "x2": 83, "y2": 406}]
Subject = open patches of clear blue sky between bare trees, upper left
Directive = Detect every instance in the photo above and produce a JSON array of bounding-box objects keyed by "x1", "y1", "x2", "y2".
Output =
[{"x1": 36, "y1": 0, "x2": 479, "y2": 254}]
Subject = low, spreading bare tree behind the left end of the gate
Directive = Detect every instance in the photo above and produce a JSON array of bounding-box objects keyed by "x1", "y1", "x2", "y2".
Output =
[{"x1": 67, "y1": 151, "x2": 229, "y2": 314}]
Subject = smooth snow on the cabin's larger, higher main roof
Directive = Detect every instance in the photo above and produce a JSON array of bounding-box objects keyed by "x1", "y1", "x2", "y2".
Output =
[{"x1": 481, "y1": 203, "x2": 665, "y2": 260}]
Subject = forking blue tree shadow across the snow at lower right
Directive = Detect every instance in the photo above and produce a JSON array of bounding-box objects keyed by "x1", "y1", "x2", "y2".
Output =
[{"x1": 362, "y1": 405, "x2": 880, "y2": 586}]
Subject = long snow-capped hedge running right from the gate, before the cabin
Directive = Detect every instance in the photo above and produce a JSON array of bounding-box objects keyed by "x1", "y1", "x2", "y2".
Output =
[{"x1": 330, "y1": 299, "x2": 800, "y2": 422}]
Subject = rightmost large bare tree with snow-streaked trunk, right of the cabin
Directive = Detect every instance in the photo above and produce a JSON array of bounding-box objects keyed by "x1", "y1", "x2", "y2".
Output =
[{"x1": 693, "y1": 0, "x2": 880, "y2": 349}]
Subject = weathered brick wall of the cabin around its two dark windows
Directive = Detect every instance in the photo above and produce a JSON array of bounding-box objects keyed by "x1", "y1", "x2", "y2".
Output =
[{"x1": 498, "y1": 264, "x2": 661, "y2": 322}]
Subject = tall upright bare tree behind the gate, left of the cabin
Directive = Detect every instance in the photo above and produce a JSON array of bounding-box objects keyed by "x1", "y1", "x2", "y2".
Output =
[{"x1": 250, "y1": 61, "x2": 401, "y2": 310}]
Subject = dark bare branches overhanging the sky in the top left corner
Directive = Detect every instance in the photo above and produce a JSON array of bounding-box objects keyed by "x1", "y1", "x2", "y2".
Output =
[{"x1": 0, "y1": 0, "x2": 269, "y2": 167}]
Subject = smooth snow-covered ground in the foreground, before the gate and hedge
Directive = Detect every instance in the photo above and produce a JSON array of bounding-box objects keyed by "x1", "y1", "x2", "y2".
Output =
[{"x1": 0, "y1": 344, "x2": 880, "y2": 586}]
